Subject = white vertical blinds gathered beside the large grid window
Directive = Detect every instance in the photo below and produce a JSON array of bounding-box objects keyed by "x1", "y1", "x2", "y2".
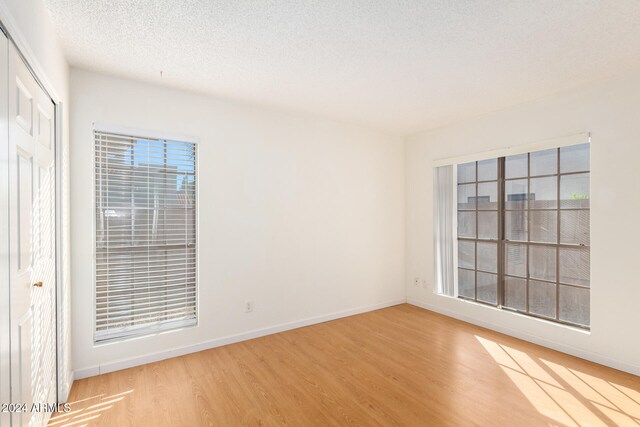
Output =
[{"x1": 433, "y1": 166, "x2": 455, "y2": 296}]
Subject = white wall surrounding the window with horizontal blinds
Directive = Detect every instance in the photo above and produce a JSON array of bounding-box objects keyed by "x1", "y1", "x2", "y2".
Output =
[{"x1": 71, "y1": 70, "x2": 405, "y2": 377}]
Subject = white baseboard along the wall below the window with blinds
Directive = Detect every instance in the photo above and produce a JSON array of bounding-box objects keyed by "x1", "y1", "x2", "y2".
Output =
[{"x1": 74, "y1": 298, "x2": 407, "y2": 380}]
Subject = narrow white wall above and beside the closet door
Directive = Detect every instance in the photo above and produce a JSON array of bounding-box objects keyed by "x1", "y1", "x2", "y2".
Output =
[{"x1": 0, "y1": 0, "x2": 73, "y2": 401}]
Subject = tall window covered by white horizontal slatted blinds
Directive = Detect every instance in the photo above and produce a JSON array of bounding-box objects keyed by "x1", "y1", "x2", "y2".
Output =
[{"x1": 94, "y1": 131, "x2": 197, "y2": 342}]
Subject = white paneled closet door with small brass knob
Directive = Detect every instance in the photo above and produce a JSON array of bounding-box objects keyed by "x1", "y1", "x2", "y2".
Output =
[{"x1": 9, "y1": 38, "x2": 56, "y2": 426}]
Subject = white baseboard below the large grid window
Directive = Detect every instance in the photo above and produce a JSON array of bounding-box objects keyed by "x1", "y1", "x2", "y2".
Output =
[{"x1": 407, "y1": 298, "x2": 640, "y2": 375}]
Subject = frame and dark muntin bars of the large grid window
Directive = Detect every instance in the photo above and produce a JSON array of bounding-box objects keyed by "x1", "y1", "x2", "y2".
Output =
[{"x1": 456, "y1": 142, "x2": 592, "y2": 330}]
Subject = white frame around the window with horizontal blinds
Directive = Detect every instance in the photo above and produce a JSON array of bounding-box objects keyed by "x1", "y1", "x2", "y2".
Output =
[{"x1": 91, "y1": 122, "x2": 200, "y2": 346}]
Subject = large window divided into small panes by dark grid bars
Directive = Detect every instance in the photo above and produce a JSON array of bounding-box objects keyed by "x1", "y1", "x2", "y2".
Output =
[{"x1": 457, "y1": 144, "x2": 590, "y2": 327}]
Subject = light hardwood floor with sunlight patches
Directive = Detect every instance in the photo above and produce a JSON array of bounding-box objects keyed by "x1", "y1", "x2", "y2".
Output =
[{"x1": 50, "y1": 304, "x2": 640, "y2": 427}]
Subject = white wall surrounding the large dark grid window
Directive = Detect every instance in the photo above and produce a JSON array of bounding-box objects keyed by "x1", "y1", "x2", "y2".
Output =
[{"x1": 406, "y1": 76, "x2": 640, "y2": 374}]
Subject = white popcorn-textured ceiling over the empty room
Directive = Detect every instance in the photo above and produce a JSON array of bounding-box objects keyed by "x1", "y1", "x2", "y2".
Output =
[{"x1": 44, "y1": 0, "x2": 640, "y2": 134}]
